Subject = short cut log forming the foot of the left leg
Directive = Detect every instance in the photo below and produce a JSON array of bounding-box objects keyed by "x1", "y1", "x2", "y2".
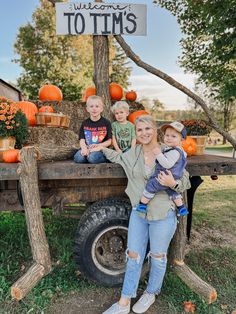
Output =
[{"x1": 11, "y1": 263, "x2": 45, "y2": 301}]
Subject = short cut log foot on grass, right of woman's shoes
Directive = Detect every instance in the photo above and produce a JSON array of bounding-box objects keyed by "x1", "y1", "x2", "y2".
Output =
[{"x1": 173, "y1": 261, "x2": 217, "y2": 304}]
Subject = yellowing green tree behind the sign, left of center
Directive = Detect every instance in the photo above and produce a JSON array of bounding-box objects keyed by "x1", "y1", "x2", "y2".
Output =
[{"x1": 15, "y1": 0, "x2": 130, "y2": 100}]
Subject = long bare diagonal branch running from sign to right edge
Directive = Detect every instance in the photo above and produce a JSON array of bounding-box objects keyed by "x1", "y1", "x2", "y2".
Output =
[{"x1": 114, "y1": 35, "x2": 236, "y2": 149}]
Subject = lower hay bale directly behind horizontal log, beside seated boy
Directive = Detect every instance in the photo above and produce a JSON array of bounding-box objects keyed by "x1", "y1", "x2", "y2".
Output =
[{"x1": 27, "y1": 126, "x2": 79, "y2": 147}]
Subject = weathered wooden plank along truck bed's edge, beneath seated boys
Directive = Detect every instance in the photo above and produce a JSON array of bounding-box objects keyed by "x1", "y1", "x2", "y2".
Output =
[{"x1": 0, "y1": 155, "x2": 236, "y2": 180}]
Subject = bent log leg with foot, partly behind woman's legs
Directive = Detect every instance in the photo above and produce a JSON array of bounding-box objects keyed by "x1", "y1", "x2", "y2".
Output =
[{"x1": 169, "y1": 193, "x2": 217, "y2": 304}]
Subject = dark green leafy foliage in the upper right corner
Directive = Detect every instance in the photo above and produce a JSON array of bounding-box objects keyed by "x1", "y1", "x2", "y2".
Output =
[{"x1": 153, "y1": 0, "x2": 236, "y2": 102}]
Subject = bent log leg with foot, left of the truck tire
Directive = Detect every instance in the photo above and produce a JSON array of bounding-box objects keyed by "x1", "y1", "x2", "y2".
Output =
[{"x1": 11, "y1": 147, "x2": 52, "y2": 300}]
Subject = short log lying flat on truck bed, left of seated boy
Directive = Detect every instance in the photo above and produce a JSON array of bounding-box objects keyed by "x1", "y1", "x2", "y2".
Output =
[{"x1": 34, "y1": 145, "x2": 79, "y2": 161}]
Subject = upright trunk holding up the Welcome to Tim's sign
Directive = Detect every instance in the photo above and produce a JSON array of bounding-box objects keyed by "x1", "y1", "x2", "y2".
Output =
[{"x1": 93, "y1": 0, "x2": 112, "y2": 119}]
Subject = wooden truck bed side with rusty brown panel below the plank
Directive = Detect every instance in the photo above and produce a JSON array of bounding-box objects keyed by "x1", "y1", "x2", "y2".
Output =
[{"x1": 0, "y1": 155, "x2": 236, "y2": 210}]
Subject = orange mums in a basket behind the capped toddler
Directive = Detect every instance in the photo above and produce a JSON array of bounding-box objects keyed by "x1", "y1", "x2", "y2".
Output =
[{"x1": 181, "y1": 119, "x2": 211, "y2": 155}]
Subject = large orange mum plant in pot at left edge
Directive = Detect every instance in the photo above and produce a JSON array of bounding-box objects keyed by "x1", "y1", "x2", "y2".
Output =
[{"x1": 0, "y1": 96, "x2": 28, "y2": 151}]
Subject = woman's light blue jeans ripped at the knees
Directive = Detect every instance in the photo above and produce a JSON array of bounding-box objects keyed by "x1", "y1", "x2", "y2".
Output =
[{"x1": 121, "y1": 209, "x2": 177, "y2": 298}]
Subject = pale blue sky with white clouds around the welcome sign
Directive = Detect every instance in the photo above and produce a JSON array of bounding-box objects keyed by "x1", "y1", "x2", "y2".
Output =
[{"x1": 0, "y1": 0, "x2": 194, "y2": 110}]
